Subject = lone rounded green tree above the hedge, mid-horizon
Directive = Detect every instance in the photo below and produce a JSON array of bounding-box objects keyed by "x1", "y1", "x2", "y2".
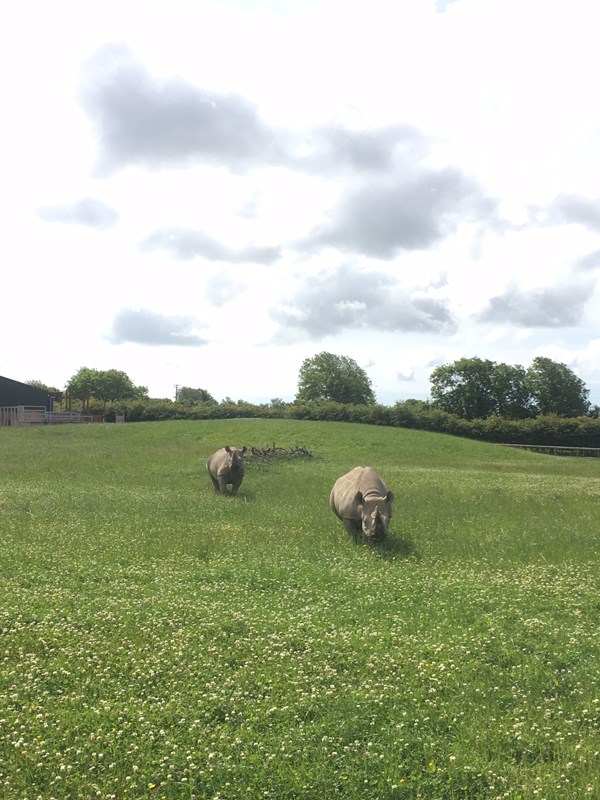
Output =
[{"x1": 296, "y1": 353, "x2": 375, "y2": 405}]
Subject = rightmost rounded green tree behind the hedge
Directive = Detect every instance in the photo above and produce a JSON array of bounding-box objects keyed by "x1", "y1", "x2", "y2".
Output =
[{"x1": 527, "y1": 356, "x2": 590, "y2": 417}]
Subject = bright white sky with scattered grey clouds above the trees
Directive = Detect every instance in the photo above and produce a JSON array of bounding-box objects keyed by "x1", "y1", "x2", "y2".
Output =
[{"x1": 0, "y1": 0, "x2": 600, "y2": 405}]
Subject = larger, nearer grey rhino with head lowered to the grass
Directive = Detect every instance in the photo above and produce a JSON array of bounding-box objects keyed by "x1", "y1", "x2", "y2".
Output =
[{"x1": 329, "y1": 467, "x2": 394, "y2": 544}]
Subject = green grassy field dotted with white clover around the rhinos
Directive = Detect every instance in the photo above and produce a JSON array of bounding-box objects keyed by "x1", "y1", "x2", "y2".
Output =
[{"x1": 0, "y1": 420, "x2": 600, "y2": 800}]
